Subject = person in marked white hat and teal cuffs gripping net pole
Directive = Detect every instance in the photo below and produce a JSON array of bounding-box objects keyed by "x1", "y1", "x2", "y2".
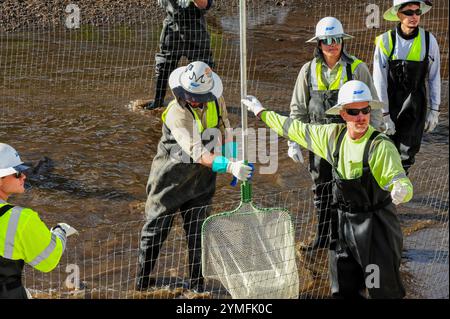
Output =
[{"x1": 136, "y1": 61, "x2": 252, "y2": 291}]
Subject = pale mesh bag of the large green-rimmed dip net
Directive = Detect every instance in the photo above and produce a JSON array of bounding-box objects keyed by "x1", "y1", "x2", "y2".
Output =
[{"x1": 202, "y1": 205, "x2": 298, "y2": 299}]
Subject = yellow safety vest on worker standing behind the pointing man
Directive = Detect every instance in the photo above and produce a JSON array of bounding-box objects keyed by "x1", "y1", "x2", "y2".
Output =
[{"x1": 310, "y1": 59, "x2": 363, "y2": 91}]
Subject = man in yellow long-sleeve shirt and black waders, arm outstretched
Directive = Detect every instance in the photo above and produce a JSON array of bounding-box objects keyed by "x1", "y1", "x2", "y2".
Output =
[{"x1": 242, "y1": 80, "x2": 413, "y2": 298}]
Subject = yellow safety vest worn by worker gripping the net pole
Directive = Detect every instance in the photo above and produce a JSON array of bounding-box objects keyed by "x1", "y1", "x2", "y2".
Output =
[{"x1": 159, "y1": 99, "x2": 223, "y2": 162}]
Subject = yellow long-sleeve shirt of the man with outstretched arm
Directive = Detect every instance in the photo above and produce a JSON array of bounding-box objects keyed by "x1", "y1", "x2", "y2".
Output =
[{"x1": 261, "y1": 111, "x2": 413, "y2": 202}]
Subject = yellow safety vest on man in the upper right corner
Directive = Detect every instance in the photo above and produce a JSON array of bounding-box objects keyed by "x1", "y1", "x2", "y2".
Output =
[{"x1": 375, "y1": 28, "x2": 425, "y2": 62}]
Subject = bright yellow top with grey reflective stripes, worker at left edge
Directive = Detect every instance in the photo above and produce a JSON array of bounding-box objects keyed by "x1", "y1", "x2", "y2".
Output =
[{"x1": 0, "y1": 201, "x2": 64, "y2": 272}]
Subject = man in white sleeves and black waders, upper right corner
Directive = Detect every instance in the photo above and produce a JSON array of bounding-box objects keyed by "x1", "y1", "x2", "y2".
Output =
[{"x1": 373, "y1": 0, "x2": 441, "y2": 172}]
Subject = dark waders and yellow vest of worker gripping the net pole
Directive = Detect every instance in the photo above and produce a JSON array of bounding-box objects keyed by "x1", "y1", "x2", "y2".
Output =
[{"x1": 136, "y1": 100, "x2": 223, "y2": 291}]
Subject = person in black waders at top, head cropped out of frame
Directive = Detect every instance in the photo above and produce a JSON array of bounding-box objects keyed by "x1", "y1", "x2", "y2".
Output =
[{"x1": 144, "y1": 0, "x2": 215, "y2": 110}]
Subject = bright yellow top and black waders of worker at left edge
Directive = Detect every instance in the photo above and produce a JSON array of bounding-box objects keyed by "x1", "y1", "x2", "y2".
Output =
[{"x1": 0, "y1": 200, "x2": 65, "y2": 284}]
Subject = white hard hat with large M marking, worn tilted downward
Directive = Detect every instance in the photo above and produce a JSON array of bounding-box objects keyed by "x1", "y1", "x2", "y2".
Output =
[{"x1": 169, "y1": 61, "x2": 223, "y2": 103}]
